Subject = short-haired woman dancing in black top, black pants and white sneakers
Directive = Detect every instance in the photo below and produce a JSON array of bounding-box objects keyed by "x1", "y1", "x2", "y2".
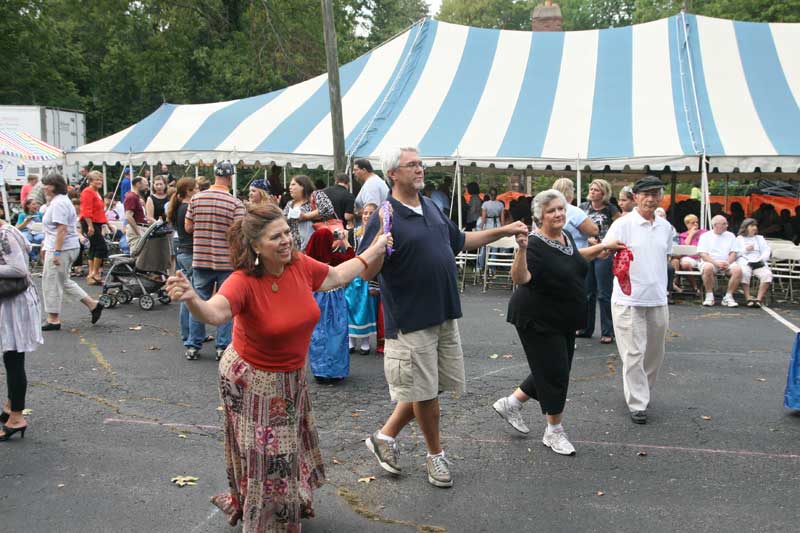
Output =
[{"x1": 492, "y1": 189, "x2": 620, "y2": 455}]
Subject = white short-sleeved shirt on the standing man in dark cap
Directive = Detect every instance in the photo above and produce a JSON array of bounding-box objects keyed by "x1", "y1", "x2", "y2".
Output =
[{"x1": 603, "y1": 208, "x2": 672, "y2": 307}]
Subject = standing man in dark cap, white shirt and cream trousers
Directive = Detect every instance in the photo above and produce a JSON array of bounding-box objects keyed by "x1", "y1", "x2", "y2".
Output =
[{"x1": 603, "y1": 176, "x2": 672, "y2": 424}]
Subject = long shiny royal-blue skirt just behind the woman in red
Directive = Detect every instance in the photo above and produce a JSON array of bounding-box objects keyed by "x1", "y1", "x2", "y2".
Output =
[{"x1": 308, "y1": 289, "x2": 350, "y2": 378}]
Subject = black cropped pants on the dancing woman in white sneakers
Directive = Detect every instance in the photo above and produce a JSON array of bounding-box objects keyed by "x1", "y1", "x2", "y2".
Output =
[{"x1": 517, "y1": 327, "x2": 575, "y2": 415}]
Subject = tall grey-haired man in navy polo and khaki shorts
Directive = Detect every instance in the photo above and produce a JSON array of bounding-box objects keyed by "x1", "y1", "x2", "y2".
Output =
[{"x1": 361, "y1": 147, "x2": 528, "y2": 487}]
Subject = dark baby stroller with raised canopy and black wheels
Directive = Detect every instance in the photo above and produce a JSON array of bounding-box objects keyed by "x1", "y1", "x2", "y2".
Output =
[{"x1": 98, "y1": 220, "x2": 172, "y2": 311}]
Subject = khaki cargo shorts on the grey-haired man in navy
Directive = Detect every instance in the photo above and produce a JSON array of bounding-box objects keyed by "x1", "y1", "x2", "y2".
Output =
[{"x1": 383, "y1": 320, "x2": 466, "y2": 402}]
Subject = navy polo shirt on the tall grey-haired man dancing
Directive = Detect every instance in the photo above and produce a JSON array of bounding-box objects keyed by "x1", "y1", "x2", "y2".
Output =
[{"x1": 358, "y1": 194, "x2": 464, "y2": 339}]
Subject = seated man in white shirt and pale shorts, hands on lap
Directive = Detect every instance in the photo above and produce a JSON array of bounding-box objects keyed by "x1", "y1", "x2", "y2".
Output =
[{"x1": 697, "y1": 215, "x2": 742, "y2": 307}]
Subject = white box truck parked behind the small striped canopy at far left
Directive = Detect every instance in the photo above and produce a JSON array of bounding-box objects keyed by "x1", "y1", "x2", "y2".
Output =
[{"x1": 0, "y1": 105, "x2": 86, "y2": 187}]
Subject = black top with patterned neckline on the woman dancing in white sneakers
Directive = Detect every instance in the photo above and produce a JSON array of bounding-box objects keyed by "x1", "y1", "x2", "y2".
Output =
[{"x1": 507, "y1": 232, "x2": 589, "y2": 333}]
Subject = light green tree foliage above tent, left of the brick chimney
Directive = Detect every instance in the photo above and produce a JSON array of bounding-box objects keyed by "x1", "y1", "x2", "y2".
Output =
[{"x1": 436, "y1": 0, "x2": 537, "y2": 30}]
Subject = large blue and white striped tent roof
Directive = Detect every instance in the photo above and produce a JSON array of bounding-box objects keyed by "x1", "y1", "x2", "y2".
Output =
[{"x1": 68, "y1": 14, "x2": 800, "y2": 172}]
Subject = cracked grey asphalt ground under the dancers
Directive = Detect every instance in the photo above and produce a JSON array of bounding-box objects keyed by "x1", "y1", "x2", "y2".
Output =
[{"x1": 0, "y1": 278, "x2": 800, "y2": 532}]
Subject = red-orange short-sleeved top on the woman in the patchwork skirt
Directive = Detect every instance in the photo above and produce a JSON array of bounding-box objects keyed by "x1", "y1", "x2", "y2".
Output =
[{"x1": 219, "y1": 254, "x2": 329, "y2": 372}]
